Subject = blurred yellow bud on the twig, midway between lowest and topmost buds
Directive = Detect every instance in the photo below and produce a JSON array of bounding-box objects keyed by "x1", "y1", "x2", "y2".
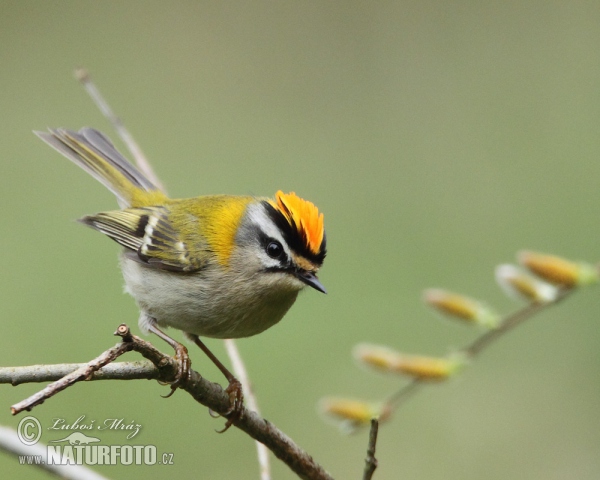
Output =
[{"x1": 423, "y1": 288, "x2": 500, "y2": 328}]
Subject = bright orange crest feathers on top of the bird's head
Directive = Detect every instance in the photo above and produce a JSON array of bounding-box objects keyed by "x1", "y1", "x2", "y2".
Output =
[{"x1": 271, "y1": 190, "x2": 325, "y2": 255}]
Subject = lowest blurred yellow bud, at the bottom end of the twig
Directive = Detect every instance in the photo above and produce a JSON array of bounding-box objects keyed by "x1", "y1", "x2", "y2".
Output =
[{"x1": 319, "y1": 398, "x2": 391, "y2": 431}]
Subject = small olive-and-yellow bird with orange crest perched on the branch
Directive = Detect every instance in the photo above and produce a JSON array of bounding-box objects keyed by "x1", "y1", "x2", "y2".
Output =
[{"x1": 35, "y1": 128, "x2": 326, "y2": 431}]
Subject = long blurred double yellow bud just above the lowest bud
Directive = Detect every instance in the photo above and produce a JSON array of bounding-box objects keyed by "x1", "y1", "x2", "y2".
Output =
[{"x1": 353, "y1": 344, "x2": 465, "y2": 381}]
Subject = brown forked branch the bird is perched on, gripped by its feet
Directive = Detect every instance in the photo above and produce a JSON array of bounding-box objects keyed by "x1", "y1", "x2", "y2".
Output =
[{"x1": 0, "y1": 325, "x2": 332, "y2": 480}]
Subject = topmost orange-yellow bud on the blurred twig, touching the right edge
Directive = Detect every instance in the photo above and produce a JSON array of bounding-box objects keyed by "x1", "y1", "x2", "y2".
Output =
[{"x1": 518, "y1": 251, "x2": 598, "y2": 287}]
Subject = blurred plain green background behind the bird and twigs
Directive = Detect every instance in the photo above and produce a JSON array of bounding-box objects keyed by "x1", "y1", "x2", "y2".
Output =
[{"x1": 0, "y1": 0, "x2": 600, "y2": 480}]
